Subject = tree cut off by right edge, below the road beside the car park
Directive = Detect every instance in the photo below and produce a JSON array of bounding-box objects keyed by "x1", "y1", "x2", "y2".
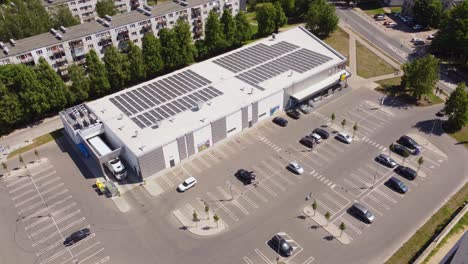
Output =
[{"x1": 445, "y1": 83, "x2": 468, "y2": 130}]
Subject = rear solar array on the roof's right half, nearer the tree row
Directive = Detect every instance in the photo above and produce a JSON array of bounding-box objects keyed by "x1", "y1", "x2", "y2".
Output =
[{"x1": 213, "y1": 41, "x2": 299, "y2": 73}]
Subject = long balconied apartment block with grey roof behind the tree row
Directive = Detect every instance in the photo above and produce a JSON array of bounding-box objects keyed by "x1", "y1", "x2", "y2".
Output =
[{"x1": 0, "y1": 0, "x2": 241, "y2": 78}]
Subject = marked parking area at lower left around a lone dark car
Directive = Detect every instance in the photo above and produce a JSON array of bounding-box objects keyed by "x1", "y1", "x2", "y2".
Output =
[{"x1": 4, "y1": 160, "x2": 110, "y2": 264}]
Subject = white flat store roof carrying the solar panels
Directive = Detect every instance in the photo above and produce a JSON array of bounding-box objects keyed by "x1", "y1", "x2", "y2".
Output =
[{"x1": 86, "y1": 27, "x2": 346, "y2": 156}]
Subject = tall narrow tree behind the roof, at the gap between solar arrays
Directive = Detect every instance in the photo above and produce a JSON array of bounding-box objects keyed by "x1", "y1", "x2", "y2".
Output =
[{"x1": 205, "y1": 10, "x2": 226, "y2": 56}]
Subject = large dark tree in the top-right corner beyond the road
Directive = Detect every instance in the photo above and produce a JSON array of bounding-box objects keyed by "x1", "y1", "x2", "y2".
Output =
[{"x1": 430, "y1": 1, "x2": 468, "y2": 67}]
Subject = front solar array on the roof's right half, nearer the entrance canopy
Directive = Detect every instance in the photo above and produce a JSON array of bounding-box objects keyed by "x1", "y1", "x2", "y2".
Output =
[{"x1": 236, "y1": 49, "x2": 332, "y2": 91}]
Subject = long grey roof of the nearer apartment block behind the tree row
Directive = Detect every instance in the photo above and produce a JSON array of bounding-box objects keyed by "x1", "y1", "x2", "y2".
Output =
[{"x1": 0, "y1": 0, "x2": 208, "y2": 59}]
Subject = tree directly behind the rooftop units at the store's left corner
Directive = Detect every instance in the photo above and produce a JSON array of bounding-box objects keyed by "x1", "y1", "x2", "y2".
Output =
[{"x1": 68, "y1": 64, "x2": 90, "y2": 104}]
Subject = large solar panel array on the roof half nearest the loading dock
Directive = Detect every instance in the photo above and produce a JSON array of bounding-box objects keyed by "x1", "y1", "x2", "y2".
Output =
[{"x1": 109, "y1": 70, "x2": 223, "y2": 128}]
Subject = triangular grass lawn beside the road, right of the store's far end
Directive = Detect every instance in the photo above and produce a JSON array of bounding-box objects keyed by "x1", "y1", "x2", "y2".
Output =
[{"x1": 356, "y1": 41, "x2": 396, "y2": 78}]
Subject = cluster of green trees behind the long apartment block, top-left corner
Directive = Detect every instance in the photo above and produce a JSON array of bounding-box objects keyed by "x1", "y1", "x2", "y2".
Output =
[{"x1": 0, "y1": 0, "x2": 80, "y2": 41}]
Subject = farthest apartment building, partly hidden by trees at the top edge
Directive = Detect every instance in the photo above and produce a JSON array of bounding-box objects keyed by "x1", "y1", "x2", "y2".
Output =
[{"x1": 42, "y1": 0, "x2": 147, "y2": 23}]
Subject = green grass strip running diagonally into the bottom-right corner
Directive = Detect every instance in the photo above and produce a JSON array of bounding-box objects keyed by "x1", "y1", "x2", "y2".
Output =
[{"x1": 386, "y1": 184, "x2": 468, "y2": 264}]
